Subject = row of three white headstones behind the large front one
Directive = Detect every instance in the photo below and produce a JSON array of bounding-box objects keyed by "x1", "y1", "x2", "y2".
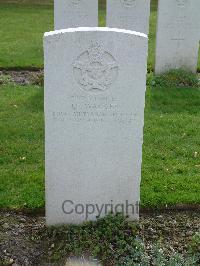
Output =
[{"x1": 55, "y1": 0, "x2": 200, "y2": 74}]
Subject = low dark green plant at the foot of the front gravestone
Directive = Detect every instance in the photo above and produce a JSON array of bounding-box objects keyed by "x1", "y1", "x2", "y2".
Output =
[{"x1": 44, "y1": 214, "x2": 144, "y2": 265}]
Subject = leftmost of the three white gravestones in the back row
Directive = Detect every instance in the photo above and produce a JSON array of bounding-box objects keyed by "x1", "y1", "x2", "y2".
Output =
[{"x1": 54, "y1": 0, "x2": 98, "y2": 30}]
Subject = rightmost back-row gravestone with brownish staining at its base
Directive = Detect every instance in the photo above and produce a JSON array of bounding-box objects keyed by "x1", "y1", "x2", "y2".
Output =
[{"x1": 155, "y1": 0, "x2": 200, "y2": 74}]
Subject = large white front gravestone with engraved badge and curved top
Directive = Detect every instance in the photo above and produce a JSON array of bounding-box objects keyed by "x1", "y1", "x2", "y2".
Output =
[{"x1": 44, "y1": 28, "x2": 148, "y2": 225}]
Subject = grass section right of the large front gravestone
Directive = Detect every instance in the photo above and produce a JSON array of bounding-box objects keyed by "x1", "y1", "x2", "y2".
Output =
[{"x1": 141, "y1": 85, "x2": 200, "y2": 206}]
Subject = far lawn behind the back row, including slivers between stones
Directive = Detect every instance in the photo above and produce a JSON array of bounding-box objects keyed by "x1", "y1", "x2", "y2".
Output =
[{"x1": 0, "y1": 0, "x2": 200, "y2": 70}]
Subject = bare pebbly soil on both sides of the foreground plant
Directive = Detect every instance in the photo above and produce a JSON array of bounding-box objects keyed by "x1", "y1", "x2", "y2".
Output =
[{"x1": 0, "y1": 211, "x2": 200, "y2": 266}]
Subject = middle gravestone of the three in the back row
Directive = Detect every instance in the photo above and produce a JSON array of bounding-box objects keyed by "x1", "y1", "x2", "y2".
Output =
[{"x1": 106, "y1": 0, "x2": 150, "y2": 34}]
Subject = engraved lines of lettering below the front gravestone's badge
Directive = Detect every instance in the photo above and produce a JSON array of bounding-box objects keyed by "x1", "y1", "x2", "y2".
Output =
[{"x1": 52, "y1": 95, "x2": 136, "y2": 125}]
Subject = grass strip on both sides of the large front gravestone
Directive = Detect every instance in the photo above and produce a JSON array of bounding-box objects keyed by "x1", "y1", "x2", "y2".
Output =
[{"x1": 0, "y1": 78, "x2": 200, "y2": 209}]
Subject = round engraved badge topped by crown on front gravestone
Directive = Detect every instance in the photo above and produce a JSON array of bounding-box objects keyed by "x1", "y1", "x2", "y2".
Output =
[{"x1": 73, "y1": 42, "x2": 119, "y2": 92}]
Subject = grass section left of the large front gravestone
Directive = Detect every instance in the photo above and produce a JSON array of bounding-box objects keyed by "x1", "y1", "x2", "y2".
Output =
[{"x1": 0, "y1": 82, "x2": 44, "y2": 208}]
